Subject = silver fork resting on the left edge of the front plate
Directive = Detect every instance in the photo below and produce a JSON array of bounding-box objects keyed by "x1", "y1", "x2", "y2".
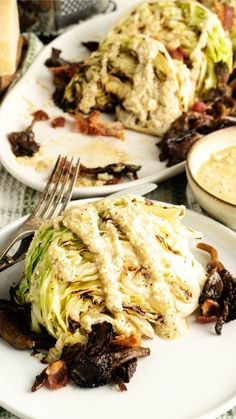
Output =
[{"x1": 0, "y1": 156, "x2": 80, "y2": 271}]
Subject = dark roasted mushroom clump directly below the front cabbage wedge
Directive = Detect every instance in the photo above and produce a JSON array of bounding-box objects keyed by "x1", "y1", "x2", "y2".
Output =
[{"x1": 63, "y1": 322, "x2": 150, "y2": 390}]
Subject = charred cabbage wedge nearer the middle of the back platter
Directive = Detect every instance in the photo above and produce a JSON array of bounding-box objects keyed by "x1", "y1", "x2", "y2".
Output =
[{"x1": 65, "y1": 34, "x2": 194, "y2": 135}]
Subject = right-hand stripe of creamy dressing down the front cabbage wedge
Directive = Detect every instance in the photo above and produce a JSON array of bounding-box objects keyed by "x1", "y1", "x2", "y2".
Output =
[{"x1": 103, "y1": 201, "x2": 186, "y2": 338}]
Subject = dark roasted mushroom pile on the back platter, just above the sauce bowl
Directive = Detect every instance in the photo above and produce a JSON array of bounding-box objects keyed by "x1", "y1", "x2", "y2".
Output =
[{"x1": 157, "y1": 61, "x2": 236, "y2": 166}]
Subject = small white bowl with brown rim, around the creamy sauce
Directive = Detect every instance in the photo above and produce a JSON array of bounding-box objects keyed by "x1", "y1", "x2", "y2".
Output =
[{"x1": 186, "y1": 127, "x2": 236, "y2": 230}]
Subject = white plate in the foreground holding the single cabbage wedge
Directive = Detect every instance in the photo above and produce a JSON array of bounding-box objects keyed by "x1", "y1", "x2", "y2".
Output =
[{"x1": 0, "y1": 202, "x2": 236, "y2": 419}]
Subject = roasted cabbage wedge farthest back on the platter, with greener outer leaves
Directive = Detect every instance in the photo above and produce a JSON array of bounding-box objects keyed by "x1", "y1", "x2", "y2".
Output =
[{"x1": 111, "y1": 0, "x2": 232, "y2": 95}]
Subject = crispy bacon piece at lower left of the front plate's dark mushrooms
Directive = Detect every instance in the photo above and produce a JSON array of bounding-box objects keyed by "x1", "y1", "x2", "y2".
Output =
[{"x1": 31, "y1": 359, "x2": 68, "y2": 391}]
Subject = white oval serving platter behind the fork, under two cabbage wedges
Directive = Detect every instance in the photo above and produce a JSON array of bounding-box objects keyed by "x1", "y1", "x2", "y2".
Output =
[{"x1": 0, "y1": 4, "x2": 184, "y2": 197}]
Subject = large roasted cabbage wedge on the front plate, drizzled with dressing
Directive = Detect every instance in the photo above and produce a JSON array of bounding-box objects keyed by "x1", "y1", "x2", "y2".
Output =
[{"x1": 15, "y1": 195, "x2": 206, "y2": 361}]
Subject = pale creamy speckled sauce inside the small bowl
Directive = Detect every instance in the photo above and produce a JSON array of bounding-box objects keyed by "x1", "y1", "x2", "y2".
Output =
[{"x1": 196, "y1": 146, "x2": 236, "y2": 205}]
